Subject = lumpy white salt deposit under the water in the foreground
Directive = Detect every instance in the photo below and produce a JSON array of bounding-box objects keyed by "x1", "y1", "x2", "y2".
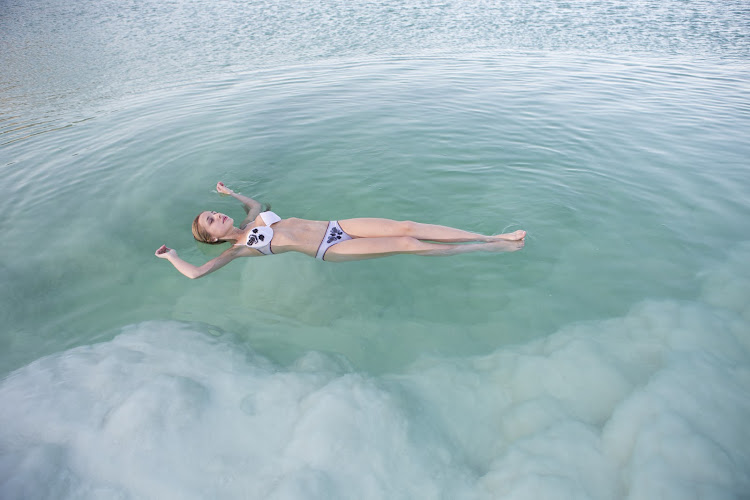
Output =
[{"x1": 0, "y1": 245, "x2": 750, "y2": 500}]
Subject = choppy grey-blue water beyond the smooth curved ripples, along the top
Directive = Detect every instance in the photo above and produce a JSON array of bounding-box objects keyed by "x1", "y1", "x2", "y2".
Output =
[{"x1": 0, "y1": 0, "x2": 750, "y2": 143}]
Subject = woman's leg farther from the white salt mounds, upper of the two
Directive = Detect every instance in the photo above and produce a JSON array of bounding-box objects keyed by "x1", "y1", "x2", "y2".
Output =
[{"x1": 339, "y1": 218, "x2": 526, "y2": 243}]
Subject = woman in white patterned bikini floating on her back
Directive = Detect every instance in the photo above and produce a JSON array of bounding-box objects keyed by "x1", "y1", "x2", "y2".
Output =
[{"x1": 156, "y1": 182, "x2": 526, "y2": 279}]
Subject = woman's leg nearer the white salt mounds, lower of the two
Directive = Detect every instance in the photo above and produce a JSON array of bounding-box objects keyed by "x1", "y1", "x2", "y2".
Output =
[{"x1": 324, "y1": 236, "x2": 523, "y2": 262}]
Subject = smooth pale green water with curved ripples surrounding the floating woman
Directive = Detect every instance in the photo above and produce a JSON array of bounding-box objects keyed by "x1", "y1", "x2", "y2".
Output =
[{"x1": 3, "y1": 55, "x2": 749, "y2": 376}]
